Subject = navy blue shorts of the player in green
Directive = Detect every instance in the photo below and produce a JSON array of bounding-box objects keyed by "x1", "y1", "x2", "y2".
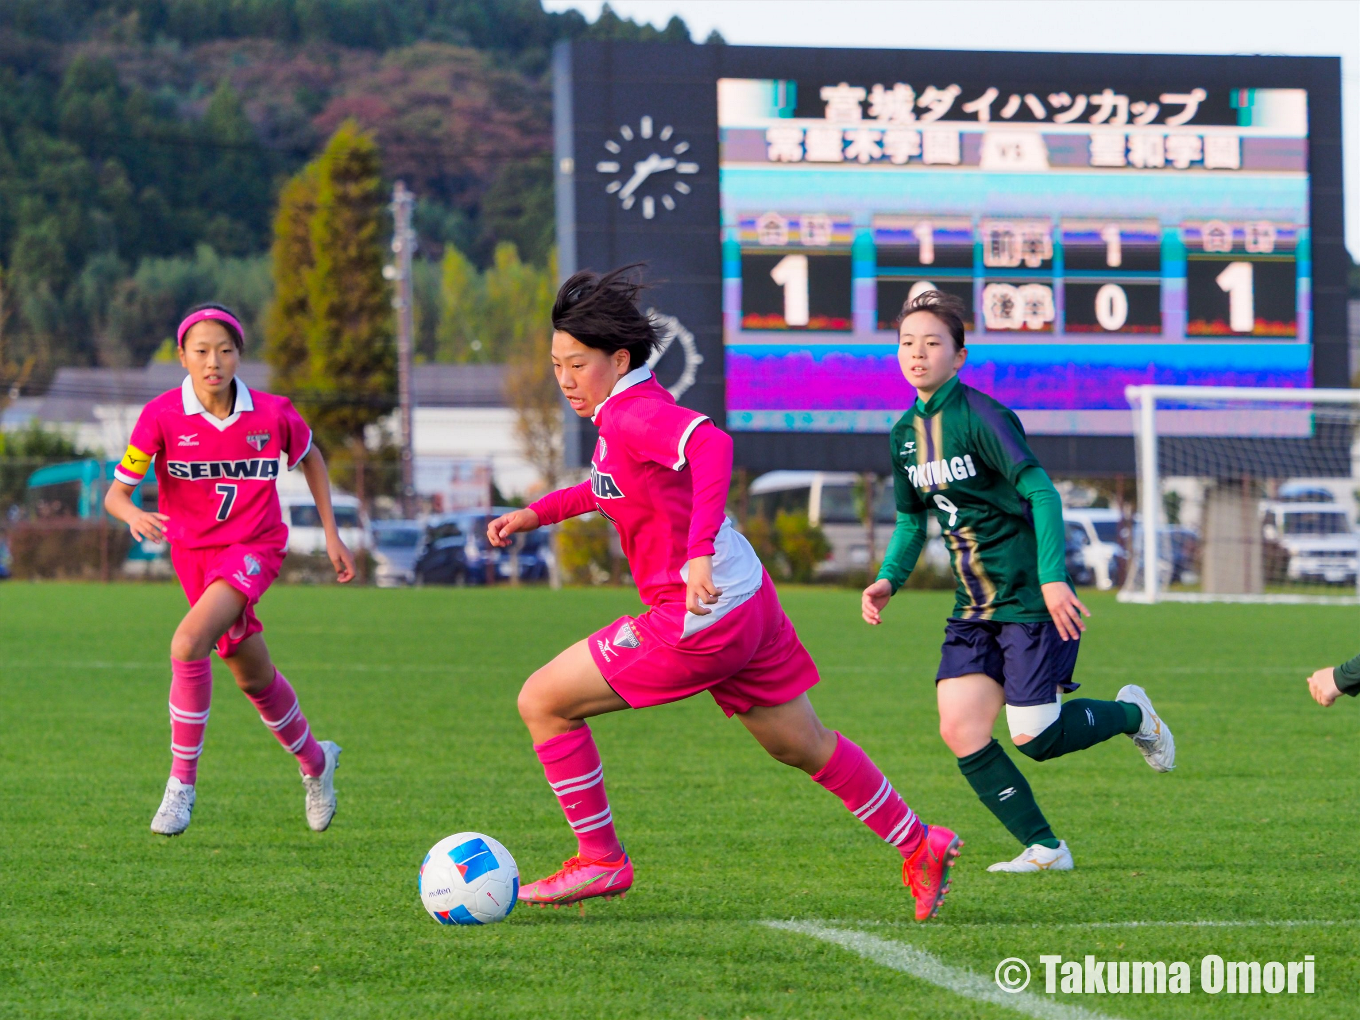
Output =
[{"x1": 936, "y1": 617, "x2": 1081, "y2": 709}]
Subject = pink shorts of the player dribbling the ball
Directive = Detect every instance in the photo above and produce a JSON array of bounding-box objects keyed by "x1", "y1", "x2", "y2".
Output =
[{"x1": 589, "y1": 574, "x2": 821, "y2": 715}]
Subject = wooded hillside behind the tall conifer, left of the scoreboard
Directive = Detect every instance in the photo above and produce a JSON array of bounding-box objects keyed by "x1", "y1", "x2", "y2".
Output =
[{"x1": 0, "y1": 0, "x2": 723, "y2": 392}]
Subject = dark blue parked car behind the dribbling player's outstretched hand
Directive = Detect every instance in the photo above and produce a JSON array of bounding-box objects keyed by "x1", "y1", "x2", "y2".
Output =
[{"x1": 415, "y1": 506, "x2": 552, "y2": 585}]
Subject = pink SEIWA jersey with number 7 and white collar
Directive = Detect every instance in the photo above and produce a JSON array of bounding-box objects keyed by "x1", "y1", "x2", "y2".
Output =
[{"x1": 114, "y1": 378, "x2": 311, "y2": 549}]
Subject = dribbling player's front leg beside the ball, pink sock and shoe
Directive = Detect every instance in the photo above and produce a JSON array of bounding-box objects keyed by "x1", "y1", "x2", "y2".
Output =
[{"x1": 518, "y1": 641, "x2": 632, "y2": 907}]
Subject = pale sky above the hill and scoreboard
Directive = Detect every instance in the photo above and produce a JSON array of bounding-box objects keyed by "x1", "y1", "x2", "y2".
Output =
[{"x1": 543, "y1": 0, "x2": 1360, "y2": 257}]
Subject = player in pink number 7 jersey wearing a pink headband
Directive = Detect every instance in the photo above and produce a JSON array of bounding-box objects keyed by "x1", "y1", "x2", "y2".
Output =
[{"x1": 105, "y1": 305, "x2": 354, "y2": 836}]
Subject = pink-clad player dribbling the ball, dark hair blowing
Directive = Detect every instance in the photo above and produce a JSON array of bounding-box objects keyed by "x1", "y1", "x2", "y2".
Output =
[{"x1": 487, "y1": 267, "x2": 960, "y2": 921}]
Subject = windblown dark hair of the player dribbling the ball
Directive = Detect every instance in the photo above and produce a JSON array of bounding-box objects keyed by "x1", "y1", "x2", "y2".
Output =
[{"x1": 552, "y1": 262, "x2": 661, "y2": 370}]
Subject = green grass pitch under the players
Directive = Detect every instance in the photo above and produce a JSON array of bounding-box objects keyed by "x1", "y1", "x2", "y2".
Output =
[{"x1": 0, "y1": 583, "x2": 1360, "y2": 1020}]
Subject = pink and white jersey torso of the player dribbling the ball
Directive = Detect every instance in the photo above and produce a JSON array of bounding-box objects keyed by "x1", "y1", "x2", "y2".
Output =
[{"x1": 579, "y1": 369, "x2": 763, "y2": 614}]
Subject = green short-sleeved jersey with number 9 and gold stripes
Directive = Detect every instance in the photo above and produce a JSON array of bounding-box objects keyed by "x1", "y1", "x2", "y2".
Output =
[{"x1": 892, "y1": 378, "x2": 1051, "y2": 623}]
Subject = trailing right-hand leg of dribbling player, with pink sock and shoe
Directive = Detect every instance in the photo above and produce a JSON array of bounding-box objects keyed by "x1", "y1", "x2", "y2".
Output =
[{"x1": 737, "y1": 694, "x2": 963, "y2": 921}]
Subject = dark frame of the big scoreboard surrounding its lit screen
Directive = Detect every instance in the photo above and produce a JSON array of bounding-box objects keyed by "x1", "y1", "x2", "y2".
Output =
[{"x1": 552, "y1": 41, "x2": 1350, "y2": 476}]
